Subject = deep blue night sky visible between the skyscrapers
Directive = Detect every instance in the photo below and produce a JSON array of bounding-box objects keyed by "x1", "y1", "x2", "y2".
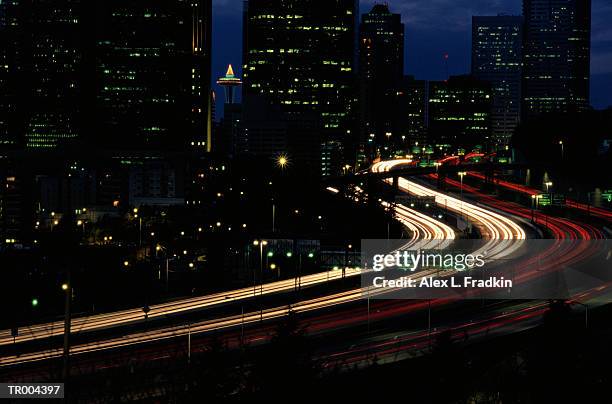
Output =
[{"x1": 213, "y1": 0, "x2": 612, "y2": 117}]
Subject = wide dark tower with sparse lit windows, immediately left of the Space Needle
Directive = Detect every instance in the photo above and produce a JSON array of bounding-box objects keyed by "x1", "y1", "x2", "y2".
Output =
[{"x1": 94, "y1": 0, "x2": 212, "y2": 151}]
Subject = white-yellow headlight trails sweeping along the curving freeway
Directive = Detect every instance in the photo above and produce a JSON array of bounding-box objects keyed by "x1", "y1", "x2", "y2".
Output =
[{"x1": 0, "y1": 161, "x2": 525, "y2": 366}]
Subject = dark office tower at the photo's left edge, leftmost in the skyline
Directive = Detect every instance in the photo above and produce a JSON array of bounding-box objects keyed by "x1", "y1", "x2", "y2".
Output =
[{"x1": 0, "y1": 0, "x2": 83, "y2": 149}]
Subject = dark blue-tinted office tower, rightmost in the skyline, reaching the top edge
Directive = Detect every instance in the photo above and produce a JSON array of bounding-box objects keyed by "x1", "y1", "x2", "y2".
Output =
[{"x1": 523, "y1": 0, "x2": 591, "y2": 119}]
